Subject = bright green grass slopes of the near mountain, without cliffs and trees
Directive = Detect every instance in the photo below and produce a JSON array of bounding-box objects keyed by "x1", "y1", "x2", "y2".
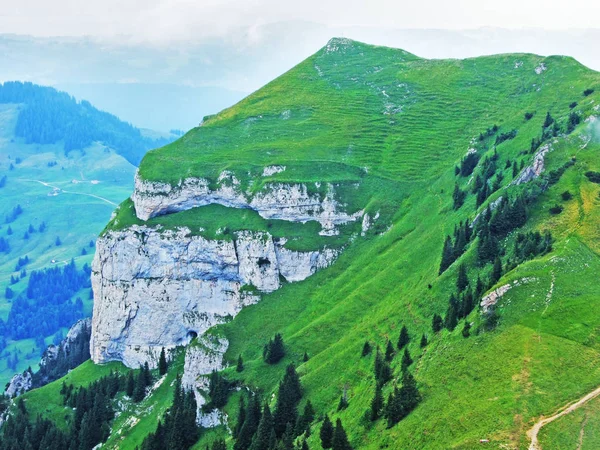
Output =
[{"x1": 16, "y1": 39, "x2": 600, "y2": 450}]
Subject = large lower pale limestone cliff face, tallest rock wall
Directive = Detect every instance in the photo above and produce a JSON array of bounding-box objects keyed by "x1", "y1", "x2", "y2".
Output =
[{"x1": 90, "y1": 226, "x2": 338, "y2": 367}]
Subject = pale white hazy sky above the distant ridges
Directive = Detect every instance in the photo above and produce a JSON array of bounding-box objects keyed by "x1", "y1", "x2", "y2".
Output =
[{"x1": 0, "y1": 0, "x2": 600, "y2": 43}]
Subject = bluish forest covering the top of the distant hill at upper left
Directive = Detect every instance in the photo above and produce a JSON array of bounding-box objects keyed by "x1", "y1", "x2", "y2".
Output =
[{"x1": 0, "y1": 82, "x2": 170, "y2": 165}]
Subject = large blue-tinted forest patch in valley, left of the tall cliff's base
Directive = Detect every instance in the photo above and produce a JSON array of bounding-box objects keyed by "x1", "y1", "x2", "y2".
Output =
[{"x1": 0, "y1": 260, "x2": 90, "y2": 339}]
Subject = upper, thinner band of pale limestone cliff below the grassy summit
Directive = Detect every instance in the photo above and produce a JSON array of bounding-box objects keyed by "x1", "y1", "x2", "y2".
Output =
[{"x1": 131, "y1": 171, "x2": 363, "y2": 235}]
